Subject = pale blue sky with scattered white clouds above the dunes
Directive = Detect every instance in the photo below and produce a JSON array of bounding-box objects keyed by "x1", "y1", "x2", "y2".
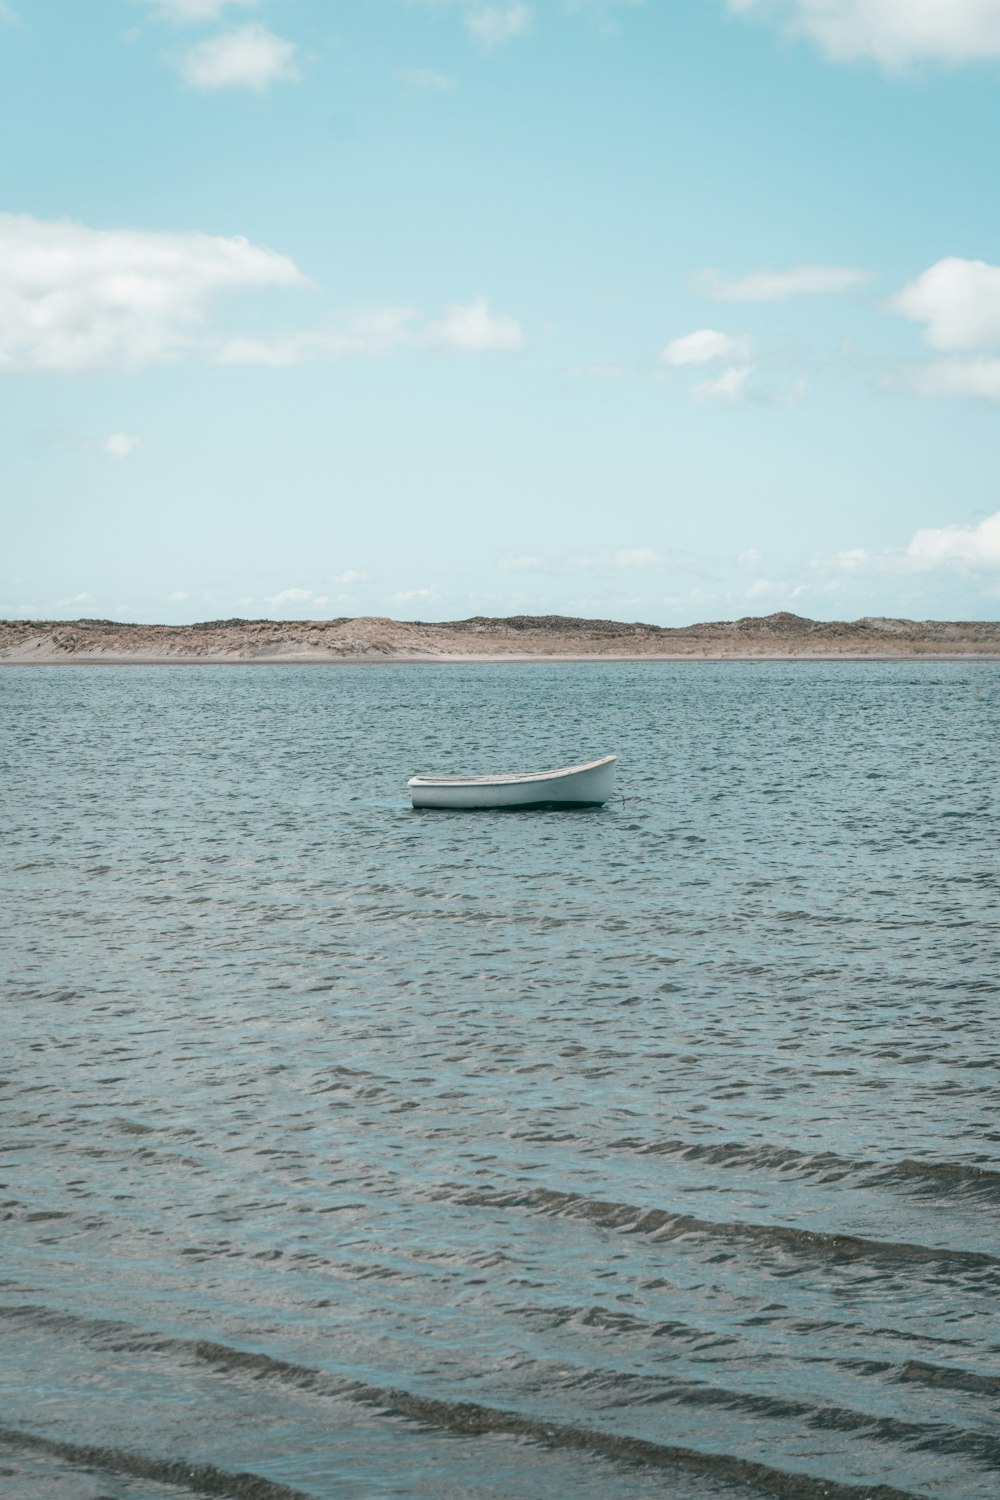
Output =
[{"x1": 0, "y1": 0, "x2": 1000, "y2": 626}]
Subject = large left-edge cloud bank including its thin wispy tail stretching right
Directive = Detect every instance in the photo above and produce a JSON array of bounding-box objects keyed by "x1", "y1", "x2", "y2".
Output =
[{"x1": 0, "y1": 215, "x2": 525, "y2": 374}]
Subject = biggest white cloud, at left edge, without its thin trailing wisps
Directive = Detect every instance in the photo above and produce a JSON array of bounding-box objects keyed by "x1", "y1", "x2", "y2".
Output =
[{"x1": 0, "y1": 215, "x2": 304, "y2": 371}]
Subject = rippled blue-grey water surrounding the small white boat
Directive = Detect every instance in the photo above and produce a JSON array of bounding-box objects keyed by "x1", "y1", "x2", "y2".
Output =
[{"x1": 0, "y1": 663, "x2": 1000, "y2": 1500}]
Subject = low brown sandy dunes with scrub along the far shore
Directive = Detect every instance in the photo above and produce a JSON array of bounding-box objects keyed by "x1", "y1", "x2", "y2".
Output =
[{"x1": 0, "y1": 612, "x2": 1000, "y2": 663}]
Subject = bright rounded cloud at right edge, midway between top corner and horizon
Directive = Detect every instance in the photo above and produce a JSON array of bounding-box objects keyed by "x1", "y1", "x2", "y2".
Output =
[{"x1": 889, "y1": 259, "x2": 1000, "y2": 350}]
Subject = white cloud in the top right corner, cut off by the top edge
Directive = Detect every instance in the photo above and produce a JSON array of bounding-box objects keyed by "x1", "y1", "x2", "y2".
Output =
[{"x1": 727, "y1": 0, "x2": 1000, "y2": 68}]
